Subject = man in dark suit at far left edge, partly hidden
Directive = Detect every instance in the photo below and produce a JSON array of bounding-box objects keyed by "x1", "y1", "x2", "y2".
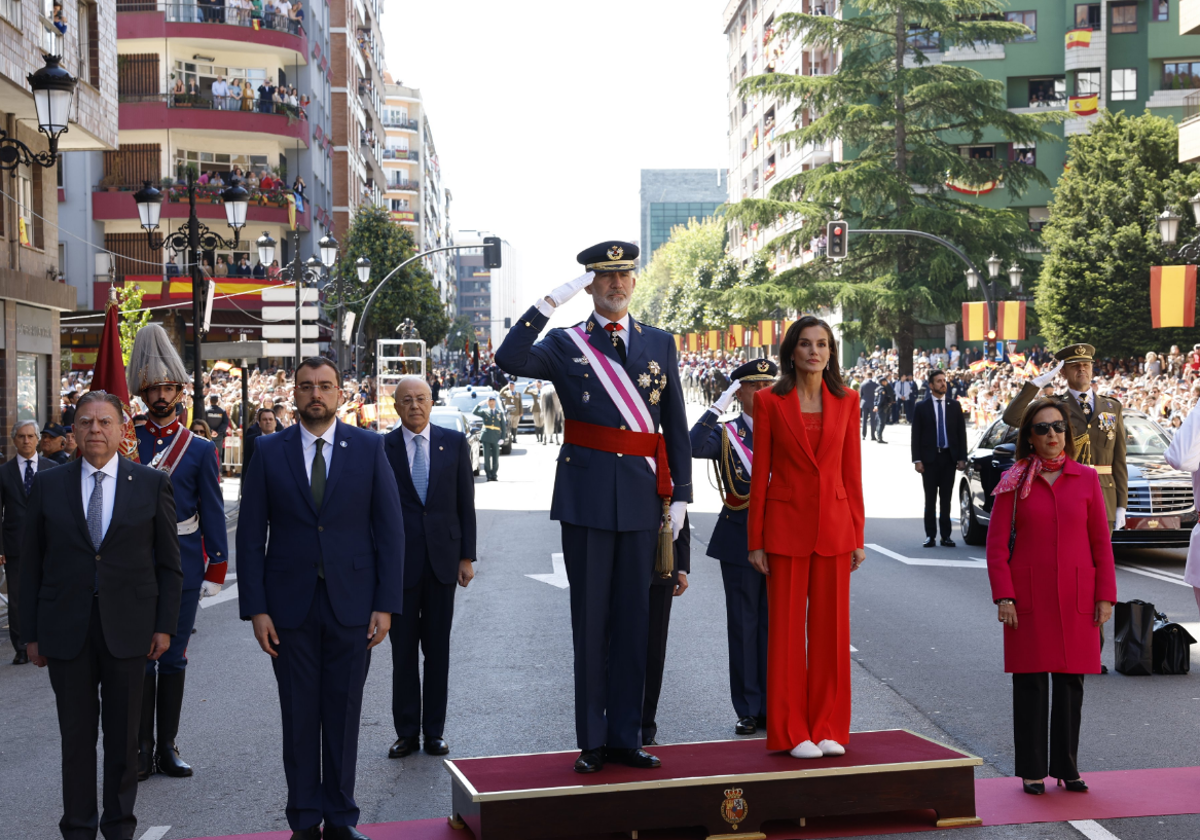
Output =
[{"x1": 0, "y1": 420, "x2": 48, "y2": 665}]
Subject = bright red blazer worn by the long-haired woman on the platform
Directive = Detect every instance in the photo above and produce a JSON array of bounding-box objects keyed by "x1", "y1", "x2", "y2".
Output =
[{"x1": 748, "y1": 383, "x2": 863, "y2": 557}]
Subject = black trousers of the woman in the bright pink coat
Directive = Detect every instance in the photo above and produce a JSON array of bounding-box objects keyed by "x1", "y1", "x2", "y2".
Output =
[{"x1": 1013, "y1": 673, "x2": 1084, "y2": 781}]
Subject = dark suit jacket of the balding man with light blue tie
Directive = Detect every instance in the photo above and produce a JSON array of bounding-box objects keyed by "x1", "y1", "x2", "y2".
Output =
[{"x1": 384, "y1": 424, "x2": 476, "y2": 589}]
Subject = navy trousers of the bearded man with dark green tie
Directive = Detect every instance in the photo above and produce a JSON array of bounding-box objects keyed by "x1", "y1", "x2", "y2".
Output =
[{"x1": 271, "y1": 581, "x2": 367, "y2": 830}]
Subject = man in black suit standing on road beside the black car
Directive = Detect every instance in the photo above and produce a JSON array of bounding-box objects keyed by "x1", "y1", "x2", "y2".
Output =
[{"x1": 912, "y1": 371, "x2": 967, "y2": 548}]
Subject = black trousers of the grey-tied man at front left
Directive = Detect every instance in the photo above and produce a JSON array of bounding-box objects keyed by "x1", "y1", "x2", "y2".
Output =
[{"x1": 47, "y1": 598, "x2": 150, "y2": 840}]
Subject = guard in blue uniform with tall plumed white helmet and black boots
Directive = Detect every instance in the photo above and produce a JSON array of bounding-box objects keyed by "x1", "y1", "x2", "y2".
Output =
[{"x1": 126, "y1": 324, "x2": 228, "y2": 780}]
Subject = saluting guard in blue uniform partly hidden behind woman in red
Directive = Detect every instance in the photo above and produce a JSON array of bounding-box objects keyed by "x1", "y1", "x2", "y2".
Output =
[{"x1": 691, "y1": 359, "x2": 779, "y2": 734}]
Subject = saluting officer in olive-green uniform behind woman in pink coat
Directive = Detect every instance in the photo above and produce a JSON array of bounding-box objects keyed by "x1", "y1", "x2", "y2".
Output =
[{"x1": 1004, "y1": 344, "x2": 1129, "y2": 529}]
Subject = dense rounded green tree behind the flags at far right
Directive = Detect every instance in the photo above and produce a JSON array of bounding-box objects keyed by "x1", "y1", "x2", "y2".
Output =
[{"x1": 1034, "y1": 112, "x2": 1200, "y2": 356}]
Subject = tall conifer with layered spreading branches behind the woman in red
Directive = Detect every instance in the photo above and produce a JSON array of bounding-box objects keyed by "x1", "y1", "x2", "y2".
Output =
[{"x1": 727, "y1": 0, "x2": 1060, "y2": 373}]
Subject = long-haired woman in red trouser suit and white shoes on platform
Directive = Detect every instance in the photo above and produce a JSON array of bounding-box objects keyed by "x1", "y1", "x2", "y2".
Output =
[{"x1": 748, "y1": 316, "x2": 866, "y2": 758}]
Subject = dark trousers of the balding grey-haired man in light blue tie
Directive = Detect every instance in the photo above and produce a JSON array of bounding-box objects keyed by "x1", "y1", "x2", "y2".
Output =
[{"x1": 389, "y1": 560, "x2": 458, "y2": 739}]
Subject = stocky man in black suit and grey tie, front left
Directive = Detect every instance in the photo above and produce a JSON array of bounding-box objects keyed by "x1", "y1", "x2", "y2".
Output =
[{"x1": 20, "y1": 391, "x2": 184, "y2": 840}]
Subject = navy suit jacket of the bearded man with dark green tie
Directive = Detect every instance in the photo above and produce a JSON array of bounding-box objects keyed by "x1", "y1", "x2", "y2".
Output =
[{"x1": 238, "y1": 420, "x2": 404, "y2": 629}]
